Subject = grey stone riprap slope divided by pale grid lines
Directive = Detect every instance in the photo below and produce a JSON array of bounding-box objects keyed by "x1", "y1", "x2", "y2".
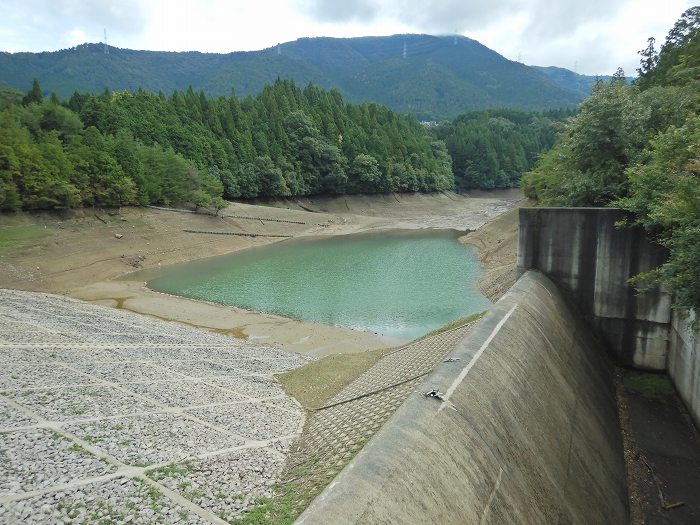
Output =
[{"x1": 0, "y1": 290, "x2": 306, "y2": 524}]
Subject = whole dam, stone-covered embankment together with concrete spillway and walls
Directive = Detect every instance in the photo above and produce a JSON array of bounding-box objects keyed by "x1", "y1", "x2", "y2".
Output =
[{"x1": 0, "y1": 205, "x2": 700, "y2": 525}]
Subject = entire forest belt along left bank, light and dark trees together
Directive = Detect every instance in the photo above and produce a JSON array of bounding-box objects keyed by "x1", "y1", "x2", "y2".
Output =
[{"x1": 0, "y1": 80, "x2": 454, "y2": 210}]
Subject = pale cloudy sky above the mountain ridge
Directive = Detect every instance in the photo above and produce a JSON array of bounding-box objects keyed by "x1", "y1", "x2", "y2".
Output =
[{"x1": 0, "y1": 0, "x2": 695, "y2": 75}]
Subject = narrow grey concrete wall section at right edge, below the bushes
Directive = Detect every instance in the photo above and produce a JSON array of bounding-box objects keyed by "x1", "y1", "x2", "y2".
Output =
[{"x1": 668, "y1": 313, "x2": 700, "y2": 428}]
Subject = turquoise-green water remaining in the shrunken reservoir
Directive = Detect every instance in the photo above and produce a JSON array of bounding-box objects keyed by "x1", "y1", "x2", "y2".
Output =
[{"x1": 148, "y1": 231, "x2": 490, "y2": 340}]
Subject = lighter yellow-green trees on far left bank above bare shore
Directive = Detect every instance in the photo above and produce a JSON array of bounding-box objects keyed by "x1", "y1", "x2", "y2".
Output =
[{"x1": 0, "y1": 82, "x2": 223, "y2": 210}]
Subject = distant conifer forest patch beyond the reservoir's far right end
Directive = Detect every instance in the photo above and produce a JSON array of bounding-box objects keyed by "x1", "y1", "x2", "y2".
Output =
[{"x1": 436, "y1": 109, "x2": 574, "y2": 189}]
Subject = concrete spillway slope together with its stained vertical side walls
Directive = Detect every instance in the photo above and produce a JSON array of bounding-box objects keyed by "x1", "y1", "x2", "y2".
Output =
[{"x1": 297, "y1": 209, "x2": 700, "y2": 524}]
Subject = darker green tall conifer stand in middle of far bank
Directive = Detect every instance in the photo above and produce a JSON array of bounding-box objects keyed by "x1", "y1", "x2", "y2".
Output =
[{"x1": 68, "y1": 80, "x2": 453, "y2": 198}]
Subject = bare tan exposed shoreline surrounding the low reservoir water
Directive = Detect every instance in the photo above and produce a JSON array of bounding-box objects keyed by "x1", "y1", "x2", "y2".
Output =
[{"x1": 0, "y1": 191, "x2": 520, "y2": 357}]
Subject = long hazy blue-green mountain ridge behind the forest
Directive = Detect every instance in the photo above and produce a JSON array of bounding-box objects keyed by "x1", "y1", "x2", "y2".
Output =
[{"x1": 0, "y1": 35, "x2": 591, "y2": 120}]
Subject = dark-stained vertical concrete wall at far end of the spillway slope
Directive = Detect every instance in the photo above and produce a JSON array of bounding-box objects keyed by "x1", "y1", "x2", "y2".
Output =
[{"x1": 518, "y1": 208, "x2": 671, "y2": 370}]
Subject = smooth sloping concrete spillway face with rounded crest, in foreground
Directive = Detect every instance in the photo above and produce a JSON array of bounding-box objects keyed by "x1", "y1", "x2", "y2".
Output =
[{"x1": 298, "y1": 272, "x2": 629, "y2": 525}]
